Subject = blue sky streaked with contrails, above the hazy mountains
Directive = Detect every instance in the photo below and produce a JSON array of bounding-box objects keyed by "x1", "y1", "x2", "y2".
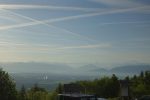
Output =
[{"x1": 0, "y1": 0, "x2": 150, "y2": 66}]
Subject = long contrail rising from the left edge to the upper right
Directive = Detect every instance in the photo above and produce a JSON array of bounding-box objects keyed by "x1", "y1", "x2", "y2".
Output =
[{"x1": 0, "y1": 6, "x2": 149, "y2": 30}]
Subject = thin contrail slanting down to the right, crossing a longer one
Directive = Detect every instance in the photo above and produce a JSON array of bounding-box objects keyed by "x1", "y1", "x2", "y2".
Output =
[{"x1": 3, "y1": 9, "x2": 95, "y2": 41}]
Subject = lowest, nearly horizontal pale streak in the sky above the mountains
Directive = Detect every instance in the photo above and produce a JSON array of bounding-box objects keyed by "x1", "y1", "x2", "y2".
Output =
[{"x1": 0, "y1": 42, "x2": 112, "y2": 52}]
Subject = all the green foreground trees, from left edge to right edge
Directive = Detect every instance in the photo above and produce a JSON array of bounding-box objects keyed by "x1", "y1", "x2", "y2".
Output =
[{"x1": 0, "y1": 69, "x2": 150, "y2": 100}]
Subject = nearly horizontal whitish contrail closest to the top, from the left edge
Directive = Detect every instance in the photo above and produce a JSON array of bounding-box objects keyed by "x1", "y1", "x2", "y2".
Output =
[{"x1": 0, "y1": 4, "x2": 100, "y2": 12}]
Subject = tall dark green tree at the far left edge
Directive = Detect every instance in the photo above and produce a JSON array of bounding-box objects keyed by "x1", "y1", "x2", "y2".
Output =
[{"x1": 0, "y1": 69, "x2": 17, "y2": 100}]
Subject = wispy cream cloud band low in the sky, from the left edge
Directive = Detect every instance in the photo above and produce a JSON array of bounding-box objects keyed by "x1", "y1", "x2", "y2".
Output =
[{"x1": 0, "y1": 41, "x2": 112, "y2": 53}]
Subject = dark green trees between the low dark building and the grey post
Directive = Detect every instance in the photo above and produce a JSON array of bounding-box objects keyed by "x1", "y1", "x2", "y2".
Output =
[{"x1": 76, "y1": 74, "x2": 120, "y2": 98}]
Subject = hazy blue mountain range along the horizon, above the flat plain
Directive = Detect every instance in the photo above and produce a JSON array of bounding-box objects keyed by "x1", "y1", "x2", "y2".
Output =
[{"x1": 0, "y1": 62, "x2": 150, "y2": 75}]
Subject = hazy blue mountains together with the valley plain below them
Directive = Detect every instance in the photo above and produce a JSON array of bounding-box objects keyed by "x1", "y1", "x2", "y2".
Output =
[{"x1": 0, "y1": 62, "x2": 150, "y2": 90}]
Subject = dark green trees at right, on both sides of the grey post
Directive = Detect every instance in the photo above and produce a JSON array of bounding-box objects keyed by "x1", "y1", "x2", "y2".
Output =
[{"x1": 58, "y1": 71, "x2": 150, "y2": 99}]
